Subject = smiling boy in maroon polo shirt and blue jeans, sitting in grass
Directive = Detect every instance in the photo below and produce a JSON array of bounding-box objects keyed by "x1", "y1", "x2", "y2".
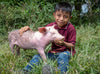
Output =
[{"x1": 20, "y1": 2, "x2": 76, "y2": 74}]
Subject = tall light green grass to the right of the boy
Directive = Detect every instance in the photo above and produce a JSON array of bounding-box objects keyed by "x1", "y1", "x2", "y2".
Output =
[{"x1": 69, "y1": 23, "x2": 100, "y2": 74}]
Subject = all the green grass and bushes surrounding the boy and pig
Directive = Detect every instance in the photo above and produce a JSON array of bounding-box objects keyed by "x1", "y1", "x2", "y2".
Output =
[{"x1": 0, "y1": 0, "x2": 100, "y2": 74}]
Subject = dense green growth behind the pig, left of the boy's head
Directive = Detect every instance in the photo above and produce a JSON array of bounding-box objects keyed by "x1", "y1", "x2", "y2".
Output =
[{"x1": 0, "y1": 0, "x2": 54, "y2": 33}]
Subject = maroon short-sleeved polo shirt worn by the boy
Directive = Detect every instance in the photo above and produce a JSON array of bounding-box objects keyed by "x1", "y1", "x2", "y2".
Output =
[{"x1": 46, "y1": 22, "x2": 76, "y2": 55}]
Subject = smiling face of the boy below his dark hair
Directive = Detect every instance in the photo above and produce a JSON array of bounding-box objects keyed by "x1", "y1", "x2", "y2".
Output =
[{"x1": 53, "y1": 10, "x2": 71, "y2": 28}]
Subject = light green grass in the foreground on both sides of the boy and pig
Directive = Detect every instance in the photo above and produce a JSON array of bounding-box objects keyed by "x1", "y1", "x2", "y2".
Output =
[{"x1": 0, "y1": 23, "x2": 100, "y2": 74}]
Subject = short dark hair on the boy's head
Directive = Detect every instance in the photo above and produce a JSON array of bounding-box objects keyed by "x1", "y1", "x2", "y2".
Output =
[{"x1": 55, "y1": 2, "x2": 72, "y2": 15}]
